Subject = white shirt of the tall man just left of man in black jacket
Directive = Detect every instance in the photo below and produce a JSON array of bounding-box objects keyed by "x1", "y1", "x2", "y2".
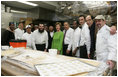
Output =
[{"x1": 80, "y1": 23, "x2": 91, "y2": 54}]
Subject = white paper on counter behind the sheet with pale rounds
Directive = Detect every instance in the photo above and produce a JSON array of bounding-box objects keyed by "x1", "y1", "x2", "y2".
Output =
[{"x1": 12, "y1": 51, "x2": 71, "y2": 66}]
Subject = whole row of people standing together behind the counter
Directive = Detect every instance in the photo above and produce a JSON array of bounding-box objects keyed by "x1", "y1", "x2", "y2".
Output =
[{"x1": 1, "y1": 15, "x2": 117, "y2": 68}]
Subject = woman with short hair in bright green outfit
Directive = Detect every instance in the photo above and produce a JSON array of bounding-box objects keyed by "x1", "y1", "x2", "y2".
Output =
[{"x1": 51, "y1": 22, "x2": 64, "y2": 54}]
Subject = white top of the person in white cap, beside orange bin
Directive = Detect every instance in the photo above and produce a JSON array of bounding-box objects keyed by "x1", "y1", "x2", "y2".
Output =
[{"x1": 22, "y1": 32, "x2": 32, "y2": 48}]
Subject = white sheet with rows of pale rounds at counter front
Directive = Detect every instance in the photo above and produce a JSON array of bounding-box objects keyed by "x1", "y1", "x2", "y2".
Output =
[{"x1": 35, "y1": 60, "x2": 96, "y2": 76}]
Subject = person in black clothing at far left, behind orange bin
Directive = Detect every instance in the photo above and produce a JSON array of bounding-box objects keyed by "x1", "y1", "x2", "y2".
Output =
[{"x1": 1, "y1": 22, "x2": 15, "y2": 45}]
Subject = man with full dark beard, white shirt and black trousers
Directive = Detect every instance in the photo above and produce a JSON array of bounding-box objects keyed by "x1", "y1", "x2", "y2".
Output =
[{"x1": 32, "y1": 24, "x2": 48, "y2": 51}]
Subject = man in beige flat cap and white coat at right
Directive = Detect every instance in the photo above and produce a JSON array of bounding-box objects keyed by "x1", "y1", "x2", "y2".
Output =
[{"x1": 95, "y1": 15, "x2": 116, "y2": 62}]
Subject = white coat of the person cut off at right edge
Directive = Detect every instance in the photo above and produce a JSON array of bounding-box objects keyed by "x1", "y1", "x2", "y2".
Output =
[{"x1": 108, "y1": 33, "x2": 117, "y2": 62}]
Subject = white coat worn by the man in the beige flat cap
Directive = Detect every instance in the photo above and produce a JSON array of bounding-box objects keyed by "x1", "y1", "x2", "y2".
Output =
[{"x1": 96, "y1": 25, "x2": 110, "y2": 62}]
